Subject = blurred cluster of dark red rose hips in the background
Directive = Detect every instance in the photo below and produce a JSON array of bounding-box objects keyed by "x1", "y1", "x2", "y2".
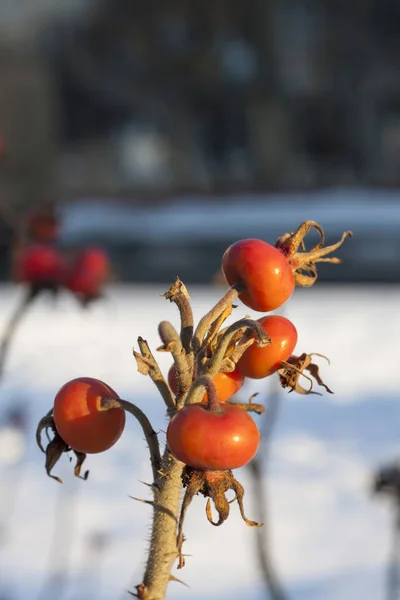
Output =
[{"x1": 13, "y1": 206, "x2": 110, "y2": 305}]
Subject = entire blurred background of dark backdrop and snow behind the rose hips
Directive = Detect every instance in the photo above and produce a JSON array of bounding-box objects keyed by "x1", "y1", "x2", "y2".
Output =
[{"x1": 0, "y1": 0, "x2": 400, "y2": 600}]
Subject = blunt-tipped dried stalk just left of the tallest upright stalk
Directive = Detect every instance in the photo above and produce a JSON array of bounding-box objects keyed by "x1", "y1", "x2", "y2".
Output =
[{"x1": 158, "y1": 321, "x2": 193, "y2": 409}]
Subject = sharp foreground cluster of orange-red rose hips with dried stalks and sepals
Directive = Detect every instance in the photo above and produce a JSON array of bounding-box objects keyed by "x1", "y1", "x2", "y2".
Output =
[{"x1": 38, "y1": 221, "x2": 351, "y2": 598}]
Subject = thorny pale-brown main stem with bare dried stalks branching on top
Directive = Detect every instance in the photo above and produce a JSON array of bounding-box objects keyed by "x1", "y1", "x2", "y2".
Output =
[{"x1": 127, "y1": 282, "x2": 276, "y2": 600}]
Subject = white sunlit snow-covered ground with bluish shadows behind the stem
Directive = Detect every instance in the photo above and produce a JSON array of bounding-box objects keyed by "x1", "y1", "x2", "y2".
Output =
[{"x1": 0, "y1": 285, "x2": 400, "y2": 600}]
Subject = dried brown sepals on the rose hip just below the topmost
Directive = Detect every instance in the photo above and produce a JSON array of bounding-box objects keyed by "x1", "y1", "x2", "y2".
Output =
[{"x1": 278, "y1": 352, "x2": 333, "y2": 396}]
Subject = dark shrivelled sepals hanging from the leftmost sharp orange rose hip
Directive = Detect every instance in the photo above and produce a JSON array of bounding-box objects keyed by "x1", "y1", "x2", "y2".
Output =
[{"x1": 36, "y1": 410, "x2": 89, "y2": 483}]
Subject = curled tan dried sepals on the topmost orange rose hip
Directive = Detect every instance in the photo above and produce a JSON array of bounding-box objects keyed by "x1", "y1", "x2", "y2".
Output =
[{"x1": 275, "y1": 221, "x2": 353, "y2": 287}]
